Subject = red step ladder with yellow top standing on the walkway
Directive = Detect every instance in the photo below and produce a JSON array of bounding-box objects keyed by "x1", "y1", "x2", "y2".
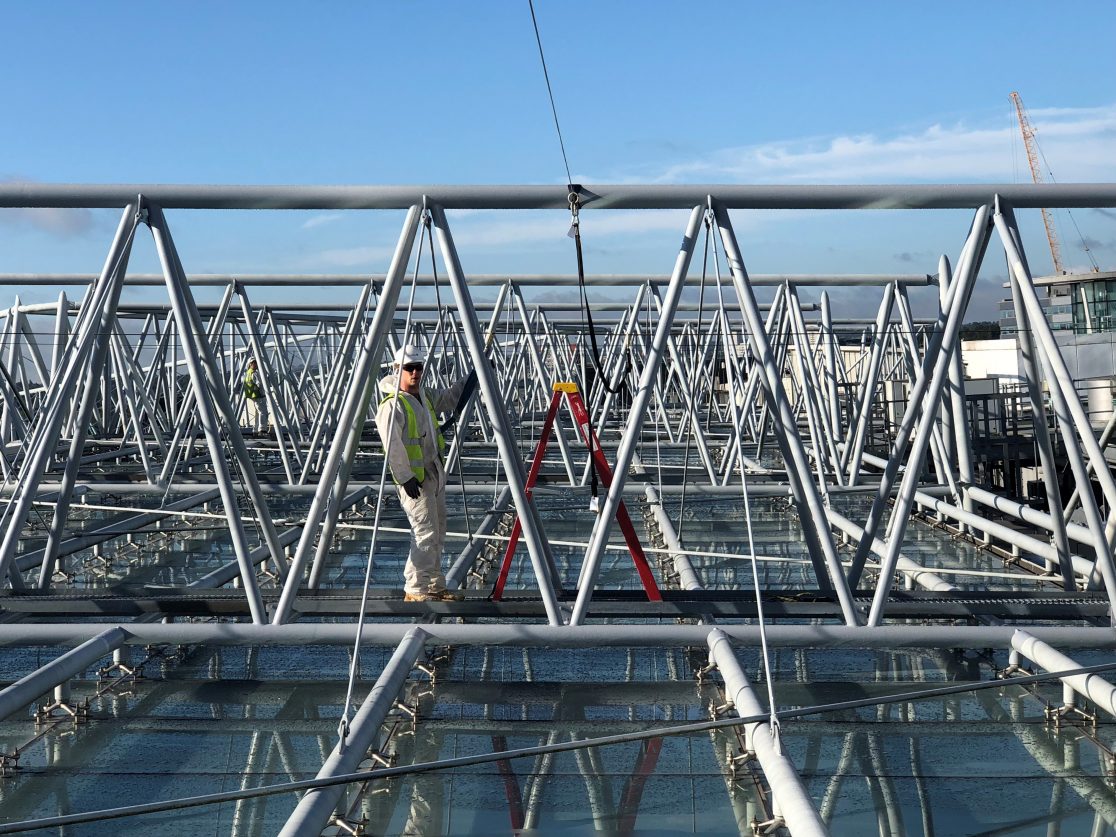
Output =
[{"x1": 490, "y1": 382, "x2": 663, "y2": 602}]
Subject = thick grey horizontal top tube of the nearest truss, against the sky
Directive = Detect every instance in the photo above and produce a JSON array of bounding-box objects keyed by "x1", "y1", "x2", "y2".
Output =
[{"x1": 0, "y1": 181, "x2": 1116, "y2": 210}]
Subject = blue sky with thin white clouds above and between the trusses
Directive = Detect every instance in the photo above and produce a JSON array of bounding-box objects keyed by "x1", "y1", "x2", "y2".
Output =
[{"x1": 0, "y1": 0, "x2": 1116, "y2": 319}]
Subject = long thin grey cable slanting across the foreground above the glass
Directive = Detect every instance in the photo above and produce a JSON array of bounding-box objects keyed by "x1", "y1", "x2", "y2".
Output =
[{"x1": 0, "y1": 663, "x2": 1116, "y2": 834}]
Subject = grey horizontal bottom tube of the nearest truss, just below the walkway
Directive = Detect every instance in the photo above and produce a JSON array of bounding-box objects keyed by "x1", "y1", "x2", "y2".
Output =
[{"x1": 0, "y1": 624, "x2": 1116, "y2": 648}]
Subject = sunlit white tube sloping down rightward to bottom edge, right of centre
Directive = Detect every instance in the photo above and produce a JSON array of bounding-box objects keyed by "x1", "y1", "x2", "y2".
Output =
[{"x1": 706, "y1": 628, "x2": 829, "y2": 837}]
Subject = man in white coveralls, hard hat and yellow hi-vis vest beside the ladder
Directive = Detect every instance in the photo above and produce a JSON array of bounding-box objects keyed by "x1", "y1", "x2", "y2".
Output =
[{"x1": 376, "y1": 346, "x2": 477, "y2": 602}]
